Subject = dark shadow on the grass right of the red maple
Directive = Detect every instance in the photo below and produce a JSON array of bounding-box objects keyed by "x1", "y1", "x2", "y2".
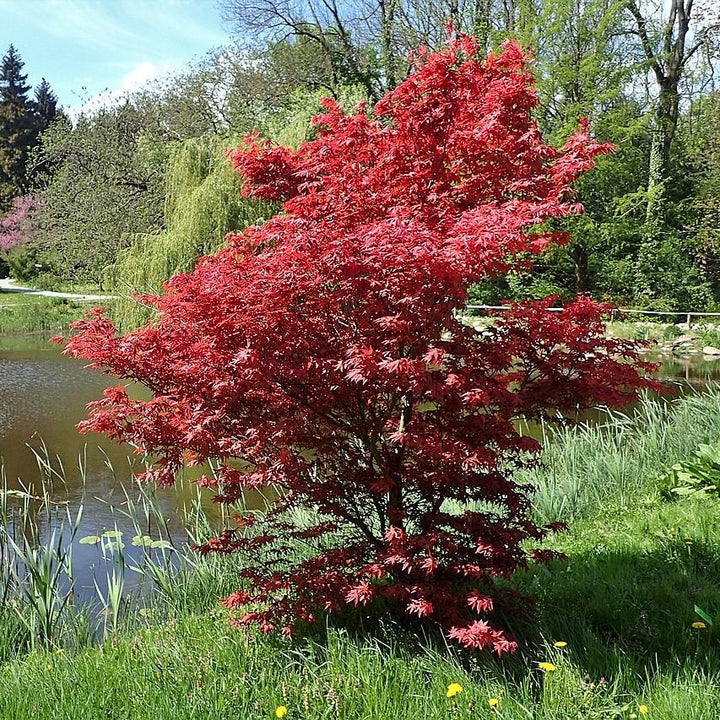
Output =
[{"x1": 515, "y1": 533, "x2": 720, "y2": 680}]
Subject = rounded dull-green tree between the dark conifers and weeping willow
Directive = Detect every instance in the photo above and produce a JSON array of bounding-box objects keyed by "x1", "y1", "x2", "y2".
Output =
[{"x1": 25, "y1": 102, "x2": 169, "y2": 284}]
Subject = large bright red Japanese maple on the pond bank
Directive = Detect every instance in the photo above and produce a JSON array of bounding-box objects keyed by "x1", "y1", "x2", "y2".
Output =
[{"x1": 67, "y1": 36, "x2": 653, "y2": 653}]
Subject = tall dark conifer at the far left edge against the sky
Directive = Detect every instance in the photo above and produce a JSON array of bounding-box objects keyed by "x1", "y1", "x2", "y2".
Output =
[{"x1": 0, "y1": 45, "x2": 38, "y2": 208}]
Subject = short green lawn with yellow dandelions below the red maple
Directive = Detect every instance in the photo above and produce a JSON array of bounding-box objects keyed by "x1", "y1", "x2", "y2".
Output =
[{"x1": 0, "y1": 498, "x2": 720, "y2": 720}]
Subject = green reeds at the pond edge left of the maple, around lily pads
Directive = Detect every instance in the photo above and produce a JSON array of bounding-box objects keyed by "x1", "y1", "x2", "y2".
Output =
[{"x1": 0, "y1": 444, "x2": 242, "y2": 662}]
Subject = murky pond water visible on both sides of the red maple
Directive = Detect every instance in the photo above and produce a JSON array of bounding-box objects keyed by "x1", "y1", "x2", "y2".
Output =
[{"x1": 0, "y1": 336, "x2": 720, "y2": 600}]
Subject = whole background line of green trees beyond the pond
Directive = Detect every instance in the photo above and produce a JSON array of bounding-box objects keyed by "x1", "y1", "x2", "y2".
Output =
[{"x1": 0, "y1": 0, "x2": 720, "y2": 310}]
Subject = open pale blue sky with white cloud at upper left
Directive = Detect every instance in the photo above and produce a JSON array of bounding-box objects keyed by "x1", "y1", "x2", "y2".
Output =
[{"x1": 0, "y1": 0, "x2": 230, "y2": 109}]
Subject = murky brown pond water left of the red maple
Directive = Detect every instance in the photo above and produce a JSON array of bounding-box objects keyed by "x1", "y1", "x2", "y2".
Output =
[{"x1": 0, "y1": 336, "x2": 233, "y2": 595}]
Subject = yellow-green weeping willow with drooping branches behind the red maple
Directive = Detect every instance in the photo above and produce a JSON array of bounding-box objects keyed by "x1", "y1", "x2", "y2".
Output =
[{"x1": 105, "y1": 137, "x2": 275, "y2": 329}]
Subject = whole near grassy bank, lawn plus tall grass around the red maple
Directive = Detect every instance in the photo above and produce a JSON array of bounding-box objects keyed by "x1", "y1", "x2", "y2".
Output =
[{"x1": 0, "y1": 393, "x2": 720, "y2": 720}]
